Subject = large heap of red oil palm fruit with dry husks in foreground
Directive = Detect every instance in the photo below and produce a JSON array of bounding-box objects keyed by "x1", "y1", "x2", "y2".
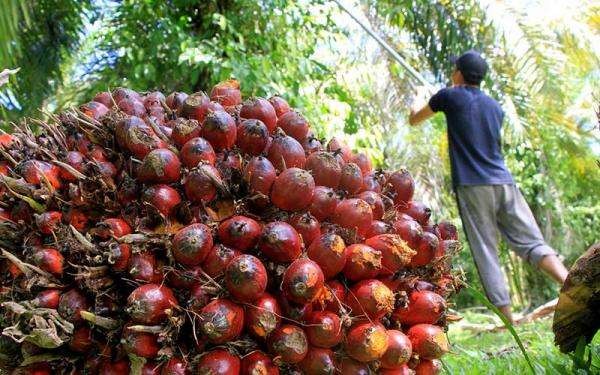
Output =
[{"x1": 0, "y1": 80, "x2": 460, "y2": 375}]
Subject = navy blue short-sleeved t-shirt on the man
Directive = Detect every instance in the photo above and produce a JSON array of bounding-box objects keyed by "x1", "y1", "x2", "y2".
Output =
[{"x1": 429, "y1": 86, "x2": 514, "y2": 186}]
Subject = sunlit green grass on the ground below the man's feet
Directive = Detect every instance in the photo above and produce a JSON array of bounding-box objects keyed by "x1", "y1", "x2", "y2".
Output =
[{"x1": 444, "y1": 311, "x2": 600, "y2": 375}]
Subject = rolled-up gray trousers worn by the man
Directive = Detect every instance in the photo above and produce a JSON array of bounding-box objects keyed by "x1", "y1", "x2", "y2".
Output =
[{"x1": 456, "y1": 184, "x2": 556, "y2": 307}]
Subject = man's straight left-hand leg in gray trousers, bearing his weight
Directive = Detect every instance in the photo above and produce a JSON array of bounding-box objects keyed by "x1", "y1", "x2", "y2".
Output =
[{"x1": 456, "y1": 185, "x2": 512, "y2": 322}]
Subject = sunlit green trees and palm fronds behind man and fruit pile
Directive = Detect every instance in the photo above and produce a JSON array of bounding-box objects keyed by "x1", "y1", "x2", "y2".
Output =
[{"x1": 0, "y1": 0, "x2": 600, "y2": 362}]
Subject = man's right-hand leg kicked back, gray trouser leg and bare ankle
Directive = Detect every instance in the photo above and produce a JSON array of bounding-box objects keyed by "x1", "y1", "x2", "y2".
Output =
[{"x1": 498, "y1": 185, "x2": 568, "y2": 284}]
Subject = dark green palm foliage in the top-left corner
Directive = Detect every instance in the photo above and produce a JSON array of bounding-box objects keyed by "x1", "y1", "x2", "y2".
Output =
[{"x1": 0, "y1": 0, "x2": 91, "y2": 119}]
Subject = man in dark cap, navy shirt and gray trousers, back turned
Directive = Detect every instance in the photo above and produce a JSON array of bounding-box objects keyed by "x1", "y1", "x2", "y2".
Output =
[{"x1": 409, "y1": 51, "x2": 567, "y2": 321}]
